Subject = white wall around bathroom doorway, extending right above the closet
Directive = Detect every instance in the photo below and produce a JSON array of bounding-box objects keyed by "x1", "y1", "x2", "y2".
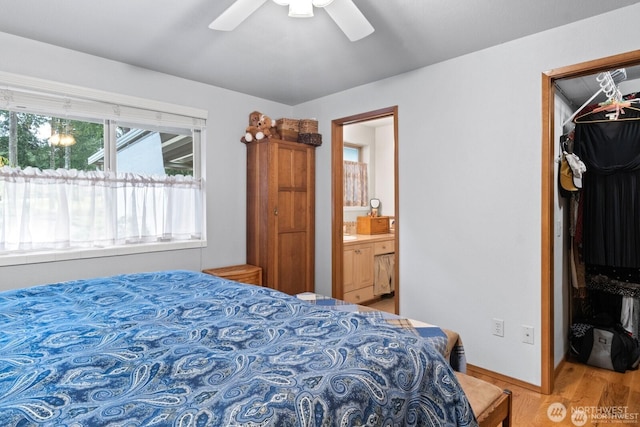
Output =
[{"x1": 295, "y1": 5, "x2": 640, "y2": 385}]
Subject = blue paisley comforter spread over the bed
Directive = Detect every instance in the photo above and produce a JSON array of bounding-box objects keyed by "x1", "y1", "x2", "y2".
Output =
[{"x1": 0, "y1": 271, "x2": 477, "y2": 427}]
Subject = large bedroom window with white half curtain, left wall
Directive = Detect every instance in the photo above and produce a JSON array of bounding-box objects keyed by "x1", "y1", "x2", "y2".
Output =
[{"x1": 0, "y1": 74, "x2": 206, "y2": 255}]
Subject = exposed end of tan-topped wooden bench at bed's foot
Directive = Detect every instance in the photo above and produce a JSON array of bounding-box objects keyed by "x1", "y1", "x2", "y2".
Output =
[{"x1": 456, "y1": 372, "x2": 512, "y2": 427}]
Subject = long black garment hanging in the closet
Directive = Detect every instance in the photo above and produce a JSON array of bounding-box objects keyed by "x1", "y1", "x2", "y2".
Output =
[{"x1": 574, "y1": 107, "x2": 640, "y2": 268}]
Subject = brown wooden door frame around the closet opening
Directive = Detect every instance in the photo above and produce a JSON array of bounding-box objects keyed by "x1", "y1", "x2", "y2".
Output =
[{"x1": 540, "y1": 50, "x2": 640, "y2": 394}]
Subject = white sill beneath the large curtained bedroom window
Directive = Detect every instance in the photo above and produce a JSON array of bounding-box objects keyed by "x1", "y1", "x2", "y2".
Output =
[{"x1": 0, "y1": 240, "x2": 207, "y2": 267}]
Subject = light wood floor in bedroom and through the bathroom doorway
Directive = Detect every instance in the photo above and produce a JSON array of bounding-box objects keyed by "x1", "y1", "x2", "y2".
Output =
[{"x1": 369, "y1": 298, "x2": 640, "y2": 427}]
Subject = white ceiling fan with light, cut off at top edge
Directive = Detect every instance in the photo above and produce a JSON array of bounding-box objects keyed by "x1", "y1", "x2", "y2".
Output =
[{"x1": 209, "y1": 0, "x2": 374, "y2": 42}]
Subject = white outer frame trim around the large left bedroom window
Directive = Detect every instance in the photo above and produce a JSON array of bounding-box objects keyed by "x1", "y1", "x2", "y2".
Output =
[{"x1": 0, "y1": 71, "x2": 208, "y2": 267}]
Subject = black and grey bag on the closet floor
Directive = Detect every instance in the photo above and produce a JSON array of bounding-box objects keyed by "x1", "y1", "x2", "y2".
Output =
[{"x1": 569, "y1": 323, "x2": 640, "y2": 372}]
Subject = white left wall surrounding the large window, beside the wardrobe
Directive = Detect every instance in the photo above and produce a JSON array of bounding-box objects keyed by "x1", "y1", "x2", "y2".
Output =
[{"x1": 0, "y1": 33, "x2": 292, "y2": 289}]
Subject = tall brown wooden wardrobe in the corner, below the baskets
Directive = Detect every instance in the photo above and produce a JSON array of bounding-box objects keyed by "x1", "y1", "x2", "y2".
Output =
[{"x1": 246, "y1": 138, "x2": 316, "y2": 295}]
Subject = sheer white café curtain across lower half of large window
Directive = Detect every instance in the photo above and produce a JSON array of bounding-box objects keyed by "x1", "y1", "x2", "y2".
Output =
[{"x1": 0, "y1": 166, "x2": 203, "y2": 253}]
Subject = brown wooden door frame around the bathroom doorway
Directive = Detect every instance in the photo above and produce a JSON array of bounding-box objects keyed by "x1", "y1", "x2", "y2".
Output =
[{"x1": 331, "y1": 105, "x2": 400, "y2": 313}]
